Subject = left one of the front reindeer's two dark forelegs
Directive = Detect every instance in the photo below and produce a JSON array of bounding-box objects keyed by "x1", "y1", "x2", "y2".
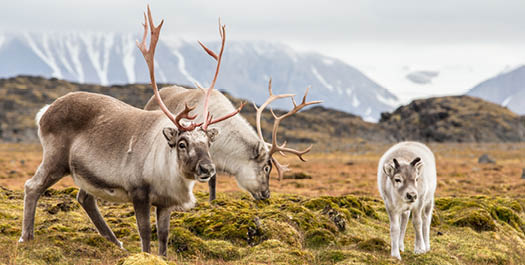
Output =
[{"x1": 131, "y1": 189, "x2": 151, "y2": 253}]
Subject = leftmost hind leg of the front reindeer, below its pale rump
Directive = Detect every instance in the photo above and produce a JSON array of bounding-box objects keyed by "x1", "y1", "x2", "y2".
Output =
[{"x1": 18, "y1": 161, "x2": 67, "y2": 242}]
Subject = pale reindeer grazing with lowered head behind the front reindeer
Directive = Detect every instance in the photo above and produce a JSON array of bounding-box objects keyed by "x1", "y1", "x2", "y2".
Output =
[{"x1": 144, "y1": 76, "x2": 321, "y2": 201}]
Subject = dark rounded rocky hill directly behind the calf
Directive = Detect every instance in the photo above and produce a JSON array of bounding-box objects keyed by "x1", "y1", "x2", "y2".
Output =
[{"x1": 379, "y1": 96, "x2": 525, "y2": 142}]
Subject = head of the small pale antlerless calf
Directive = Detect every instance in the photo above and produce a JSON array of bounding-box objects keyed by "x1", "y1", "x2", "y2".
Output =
[{"x1": 383, "y1": 157, "x2": 423, "y2": 203}]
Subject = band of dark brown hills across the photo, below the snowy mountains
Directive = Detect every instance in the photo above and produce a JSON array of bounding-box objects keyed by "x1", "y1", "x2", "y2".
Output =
[{"x1": 0, "y1": 76, "x2": 525, "y2": 144}]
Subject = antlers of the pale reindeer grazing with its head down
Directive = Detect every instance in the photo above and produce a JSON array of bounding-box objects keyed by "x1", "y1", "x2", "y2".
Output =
[{"x1": 254, "y1": 79, "x2": 322, "y2": 180}]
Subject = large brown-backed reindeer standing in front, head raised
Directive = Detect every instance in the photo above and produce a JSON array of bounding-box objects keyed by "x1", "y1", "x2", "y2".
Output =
[{"x1": 20, "y1": 6, "x2": 238, "y2": 255}]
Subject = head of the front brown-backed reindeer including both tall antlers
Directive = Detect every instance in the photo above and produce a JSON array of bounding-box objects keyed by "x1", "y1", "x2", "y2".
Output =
[{"x1": 137, "y1": 5, "x2": 244, "y2": 182}]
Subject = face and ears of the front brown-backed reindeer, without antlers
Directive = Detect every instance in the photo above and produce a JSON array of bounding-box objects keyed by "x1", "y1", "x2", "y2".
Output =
[{"x1": 162, "y1": 127, "x2": 219, "y2": 182}]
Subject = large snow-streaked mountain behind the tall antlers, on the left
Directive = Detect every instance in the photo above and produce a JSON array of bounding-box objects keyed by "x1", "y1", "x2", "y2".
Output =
[{"x1": 0, "y1": 32, "x2": 398, "y2": 121}]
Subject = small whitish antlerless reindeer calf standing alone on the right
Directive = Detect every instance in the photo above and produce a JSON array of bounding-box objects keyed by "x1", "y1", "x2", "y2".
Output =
[{"x1": 377, "y1": 142, "x2": 436, "y2": 259}]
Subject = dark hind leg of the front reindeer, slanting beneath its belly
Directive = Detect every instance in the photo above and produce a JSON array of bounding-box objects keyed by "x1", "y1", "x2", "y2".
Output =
[{"x1": 77, "y1": 189, "x2": 124, "y2": 249}]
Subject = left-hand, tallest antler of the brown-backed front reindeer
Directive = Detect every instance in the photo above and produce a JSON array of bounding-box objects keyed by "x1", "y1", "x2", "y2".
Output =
[{"x1": 137, "y1": 5, "x2": 202, "y2": 131}]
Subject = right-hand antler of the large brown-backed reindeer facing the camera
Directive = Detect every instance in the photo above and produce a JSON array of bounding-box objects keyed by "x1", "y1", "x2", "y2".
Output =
[{"x1": 197, "y1": 18, "x2": 244, "y2": 131}]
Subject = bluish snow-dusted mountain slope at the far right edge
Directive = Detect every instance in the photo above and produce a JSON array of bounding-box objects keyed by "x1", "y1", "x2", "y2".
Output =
[{"x1": 467, "y1": 66, "x2": 525, "y2": 115}]
